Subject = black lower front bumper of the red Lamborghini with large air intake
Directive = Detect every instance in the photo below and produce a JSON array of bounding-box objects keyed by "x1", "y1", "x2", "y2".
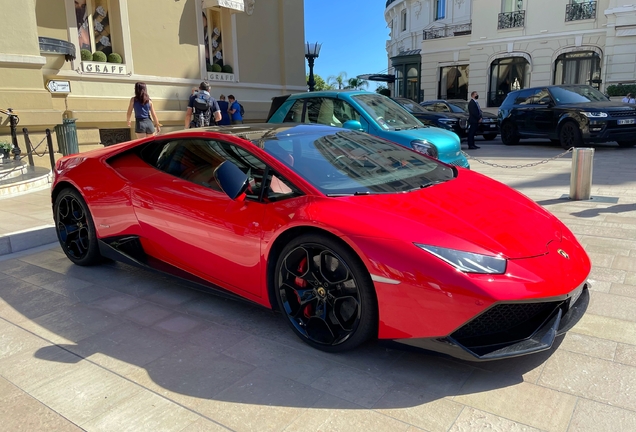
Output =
[{"x1": 395, "y1": 281, "x2": 590, "y2": 361}]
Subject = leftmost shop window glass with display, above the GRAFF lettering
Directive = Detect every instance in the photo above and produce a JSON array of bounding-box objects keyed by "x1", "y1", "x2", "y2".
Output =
[{"x1": 75, "y1": 0, "x2": 113, "y2": 56}]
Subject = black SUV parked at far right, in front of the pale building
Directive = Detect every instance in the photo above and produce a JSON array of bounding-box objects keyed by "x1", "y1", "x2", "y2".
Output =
[{"x1": 498, "y1": 85, "x2": 636, "y2": 149}]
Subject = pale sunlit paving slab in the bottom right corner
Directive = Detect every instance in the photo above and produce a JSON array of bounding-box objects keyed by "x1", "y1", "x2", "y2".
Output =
[{"x1": 569, "y1": 398, "x2": 636, "y2": 432}]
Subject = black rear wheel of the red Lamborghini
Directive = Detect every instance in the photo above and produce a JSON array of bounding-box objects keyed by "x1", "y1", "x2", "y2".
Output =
[{"x1": 53, "y1": 188, "x2": 102, "y2": 266}]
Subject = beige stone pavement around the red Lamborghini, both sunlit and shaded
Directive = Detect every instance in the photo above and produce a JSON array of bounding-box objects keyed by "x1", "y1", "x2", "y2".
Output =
[{"x1": 0, "y1": 141, "x2": 636, "y2": 432}]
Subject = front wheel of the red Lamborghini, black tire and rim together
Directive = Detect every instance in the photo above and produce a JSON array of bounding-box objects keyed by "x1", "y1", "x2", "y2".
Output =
[{"x1": 274, "y1": 234, "x2": 378, "y2": 352}]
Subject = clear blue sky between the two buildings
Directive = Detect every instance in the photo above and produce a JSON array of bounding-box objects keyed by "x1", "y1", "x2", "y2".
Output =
[{"x1": 304, "y1": 0, "x2": 389, "y2": 90}]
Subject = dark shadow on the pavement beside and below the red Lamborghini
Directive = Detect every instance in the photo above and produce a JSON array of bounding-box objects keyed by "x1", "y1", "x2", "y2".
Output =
[{"x1": 0, "y1": 249, "x2": 561, "y2": 411}]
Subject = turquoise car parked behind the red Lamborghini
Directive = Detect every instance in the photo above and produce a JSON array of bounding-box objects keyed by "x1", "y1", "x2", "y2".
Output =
[{"x1": 267, "y1": 90, "x2": 470, "y2": 168}]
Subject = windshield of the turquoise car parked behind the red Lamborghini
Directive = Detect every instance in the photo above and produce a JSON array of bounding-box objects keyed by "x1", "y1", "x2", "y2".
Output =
[{"x1": 351, "y1": 93, "x2": 425, "y2": 131}]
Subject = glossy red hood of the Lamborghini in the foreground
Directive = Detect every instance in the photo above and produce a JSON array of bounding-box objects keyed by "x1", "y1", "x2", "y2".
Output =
[{"x1": 328, "y1": 170, "x2": 562, "y2": 259}]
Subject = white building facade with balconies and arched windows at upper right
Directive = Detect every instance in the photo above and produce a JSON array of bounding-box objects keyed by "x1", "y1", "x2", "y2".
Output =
[{"x1": 385, "y1": 0, "x2": 636, "y2": 107}]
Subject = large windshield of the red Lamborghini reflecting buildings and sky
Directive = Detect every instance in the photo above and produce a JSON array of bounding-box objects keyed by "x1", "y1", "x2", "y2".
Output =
[{"x1": 255, "y1": 126, "x2": 456, "y2": 196}]
